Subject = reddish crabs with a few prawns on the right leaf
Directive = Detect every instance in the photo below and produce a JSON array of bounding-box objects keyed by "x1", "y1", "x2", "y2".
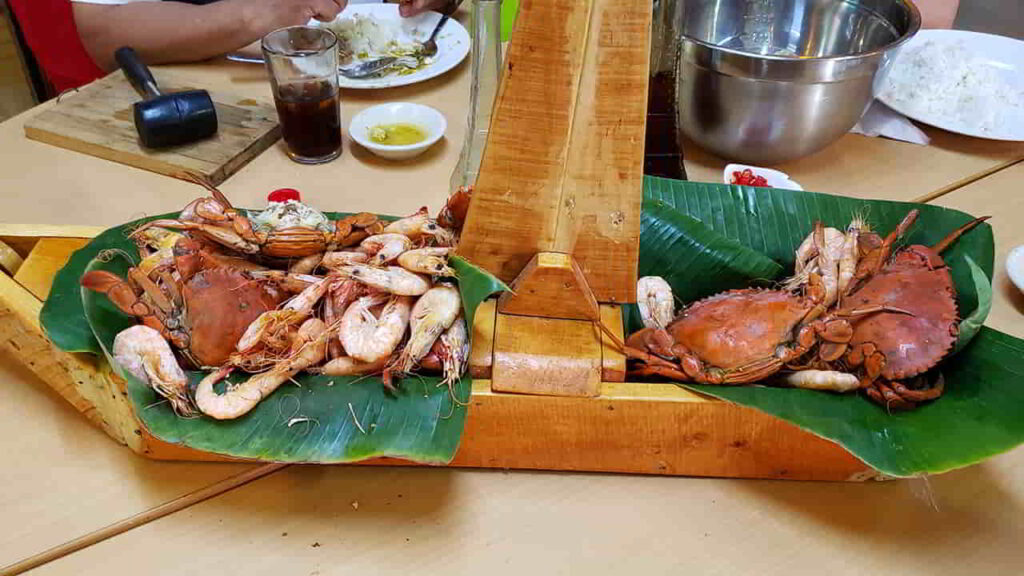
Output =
[{"x1": 626, "y1": 210, "x2": 986, "y2": 409}]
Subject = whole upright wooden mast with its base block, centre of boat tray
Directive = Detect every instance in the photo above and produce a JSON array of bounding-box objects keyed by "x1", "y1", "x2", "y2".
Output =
[{"x1": 459, "y1": 0, "x2": 652, "y2": 396}]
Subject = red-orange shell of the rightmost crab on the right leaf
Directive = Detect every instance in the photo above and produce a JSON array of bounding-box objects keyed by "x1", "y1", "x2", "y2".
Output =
[{"x1": 843, "y1": 245, "x2": 958, "y2": 380}]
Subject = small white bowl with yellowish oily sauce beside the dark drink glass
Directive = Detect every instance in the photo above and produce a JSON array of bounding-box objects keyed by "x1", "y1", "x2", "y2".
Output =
[{"x1": 348, "y1": 102, "x2": 447, "y2": 160}]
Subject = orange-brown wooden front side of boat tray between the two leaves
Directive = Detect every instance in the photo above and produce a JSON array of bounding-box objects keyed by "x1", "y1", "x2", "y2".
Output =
[{"x1": 452, "y1": 379, "x2": 877, "y2": 481}]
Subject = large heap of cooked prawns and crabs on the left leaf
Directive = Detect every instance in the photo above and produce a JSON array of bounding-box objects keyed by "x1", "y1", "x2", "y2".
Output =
[{"x1": 81, "y1": 187, "x2": 468, "y2": 419}]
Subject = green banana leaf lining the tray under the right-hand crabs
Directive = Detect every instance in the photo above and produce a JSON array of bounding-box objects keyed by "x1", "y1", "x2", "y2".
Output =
[{"x1": 641, "y1": 177, "x2": 1024, "y2": 477}]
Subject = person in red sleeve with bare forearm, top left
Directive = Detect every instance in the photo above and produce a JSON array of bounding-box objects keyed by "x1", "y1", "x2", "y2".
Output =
[{"x1": 8, "y1": 0, "x2": 451, "y2": 93}]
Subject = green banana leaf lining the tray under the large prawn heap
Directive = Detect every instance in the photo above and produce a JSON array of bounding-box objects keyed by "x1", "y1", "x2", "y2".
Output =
[{"x1": 41, "y1": 214, "x2": 506, "y2": 464}]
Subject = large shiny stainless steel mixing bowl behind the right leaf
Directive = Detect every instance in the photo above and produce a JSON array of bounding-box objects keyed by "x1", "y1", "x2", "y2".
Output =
[{"x1": 679, "y1": 0, "x2": 921, "y2": 165}]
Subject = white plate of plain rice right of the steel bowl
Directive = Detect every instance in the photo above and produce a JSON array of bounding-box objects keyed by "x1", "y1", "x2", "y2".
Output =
[{"x1": 878, "y1": 30, "x2": 1024, "y2": 141}]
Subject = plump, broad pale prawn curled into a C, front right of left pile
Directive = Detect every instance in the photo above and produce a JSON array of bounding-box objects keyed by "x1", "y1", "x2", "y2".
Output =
[{"x1": 338, "y1": 294, "x2": 413, "y2": 362}]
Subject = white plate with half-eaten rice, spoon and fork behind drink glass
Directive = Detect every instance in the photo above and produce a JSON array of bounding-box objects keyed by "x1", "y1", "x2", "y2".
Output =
[{"x1": 227, "y1": 4, "x2": 471, "y2": 89}]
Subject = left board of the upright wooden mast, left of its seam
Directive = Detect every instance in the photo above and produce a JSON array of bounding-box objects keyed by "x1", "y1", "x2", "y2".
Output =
[{"x1": 459, "y1": 0, "x2": 593, "y2": 282}]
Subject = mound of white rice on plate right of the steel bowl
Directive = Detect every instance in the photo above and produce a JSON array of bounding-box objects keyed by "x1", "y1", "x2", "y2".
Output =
[{"x1": 882, "y1": 41, "x2": 1024, "y2": 133}]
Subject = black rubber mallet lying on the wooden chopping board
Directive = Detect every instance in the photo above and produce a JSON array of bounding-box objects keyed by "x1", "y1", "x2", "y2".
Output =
[{"x1": 114, "y1": 46, "x2": 217, "y2": 148}]
